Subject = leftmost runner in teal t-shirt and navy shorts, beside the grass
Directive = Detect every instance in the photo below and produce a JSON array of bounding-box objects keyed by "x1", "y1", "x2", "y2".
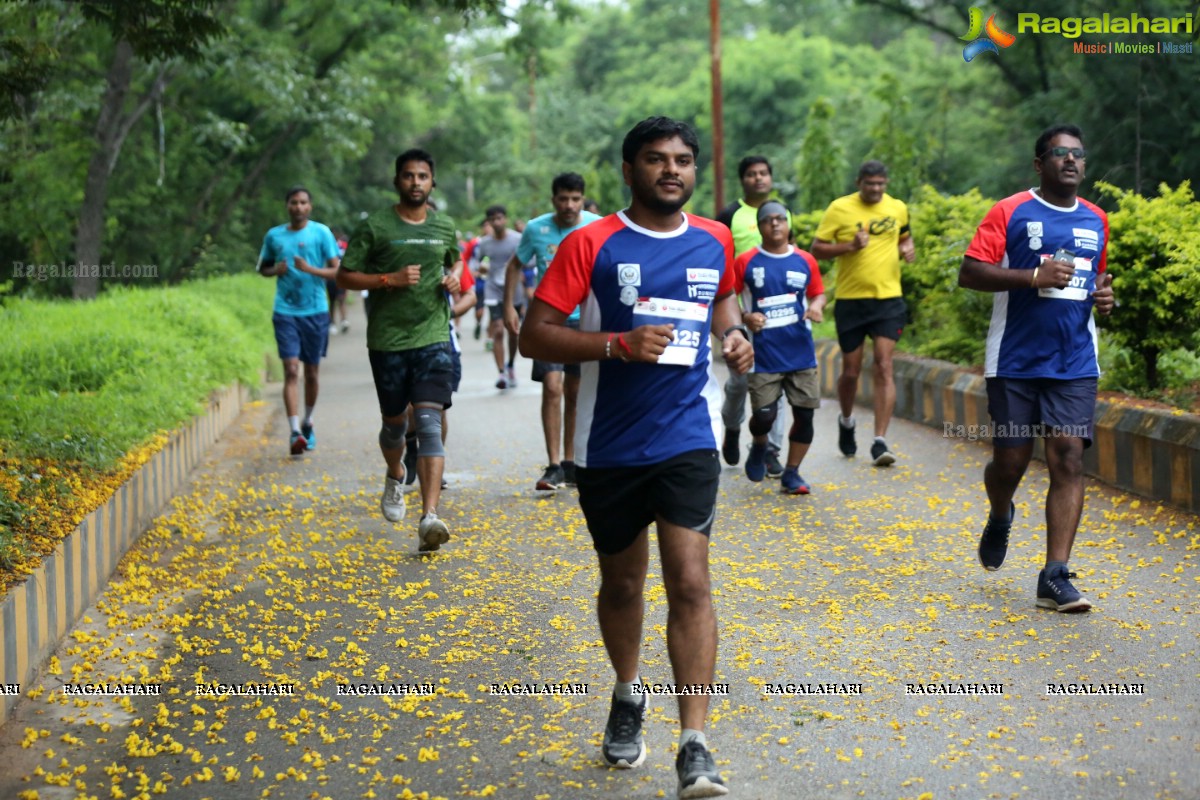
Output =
[{"x1": 258, "y1": 186, "x2": 341, "y2": 456}]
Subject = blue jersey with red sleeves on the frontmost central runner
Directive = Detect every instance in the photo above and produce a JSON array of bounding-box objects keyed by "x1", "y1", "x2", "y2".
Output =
[{"x1": 536, "y1": 211, "x2": 733, "y2": 467}]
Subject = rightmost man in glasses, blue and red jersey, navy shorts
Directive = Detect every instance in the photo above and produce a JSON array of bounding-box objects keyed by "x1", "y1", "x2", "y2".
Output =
[{"x1": 959, "y1": 125, "x2": 1114, "y2": 612}]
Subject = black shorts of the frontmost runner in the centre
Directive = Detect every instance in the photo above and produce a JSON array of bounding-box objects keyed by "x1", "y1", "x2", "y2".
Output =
[{"x1": 575, "y1": 450, "x2": 721, "y2": 555}]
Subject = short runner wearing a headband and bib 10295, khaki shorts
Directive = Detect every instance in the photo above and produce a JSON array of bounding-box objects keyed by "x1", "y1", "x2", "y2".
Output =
[{"x1": 733, "y1": 200, "x2": 826, "y2": 494}]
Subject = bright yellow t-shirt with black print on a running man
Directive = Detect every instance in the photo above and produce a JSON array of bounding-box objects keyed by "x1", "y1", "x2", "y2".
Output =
[{"x1": 816, "y1": 192, "x2": 908, "y2": 300}]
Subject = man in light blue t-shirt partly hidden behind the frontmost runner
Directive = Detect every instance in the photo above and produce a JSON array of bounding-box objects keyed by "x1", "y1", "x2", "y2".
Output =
[{"x1": 504, "y1": 173, "x2": 600, "y2": 492}]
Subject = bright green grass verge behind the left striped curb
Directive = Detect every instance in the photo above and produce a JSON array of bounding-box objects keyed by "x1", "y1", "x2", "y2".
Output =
[{"x1": 0, "y1": 275, "x2": 275, "y2": 469}]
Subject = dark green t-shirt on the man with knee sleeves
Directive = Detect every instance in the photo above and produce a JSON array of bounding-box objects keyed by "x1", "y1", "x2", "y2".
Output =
[{"x1": 342, "y1": 206, "x2": 458, "y2": 353}]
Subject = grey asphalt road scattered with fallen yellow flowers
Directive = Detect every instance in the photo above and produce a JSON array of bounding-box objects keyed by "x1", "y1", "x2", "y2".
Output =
[{"x1": 0, "y1": 306, "x2": 1200, "y2": 800}]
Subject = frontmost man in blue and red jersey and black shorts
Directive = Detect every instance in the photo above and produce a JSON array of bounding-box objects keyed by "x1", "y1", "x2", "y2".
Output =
[{"x1": 521, "y1": 116, "x2": 754, "y2": 798}]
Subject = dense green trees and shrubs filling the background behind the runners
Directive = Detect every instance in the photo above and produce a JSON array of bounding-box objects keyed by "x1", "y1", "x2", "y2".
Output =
[{"x1": 0, "y1": 0, "x2": 1200, "y2": 398}]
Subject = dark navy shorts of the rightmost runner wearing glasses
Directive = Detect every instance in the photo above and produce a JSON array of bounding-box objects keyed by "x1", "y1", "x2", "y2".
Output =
[{"x1": 988, "y1": 378, "x2": 1097, "y2": 447}]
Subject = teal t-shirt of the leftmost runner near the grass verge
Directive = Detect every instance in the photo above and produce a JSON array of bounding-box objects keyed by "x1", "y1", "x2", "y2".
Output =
[{"x1": 258, "y1": 219, "x2": 338, "y2": 317}]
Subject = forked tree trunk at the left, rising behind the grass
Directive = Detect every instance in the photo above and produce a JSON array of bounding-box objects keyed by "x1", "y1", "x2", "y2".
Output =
[{"x1": 72, "y1": 38, "x2": 170, "y2": 300}]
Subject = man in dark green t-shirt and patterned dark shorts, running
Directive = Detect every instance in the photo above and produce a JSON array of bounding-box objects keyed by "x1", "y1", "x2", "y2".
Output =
[{"x1": 337, "y1": 150, "x2": 462, "y2": 551}]
